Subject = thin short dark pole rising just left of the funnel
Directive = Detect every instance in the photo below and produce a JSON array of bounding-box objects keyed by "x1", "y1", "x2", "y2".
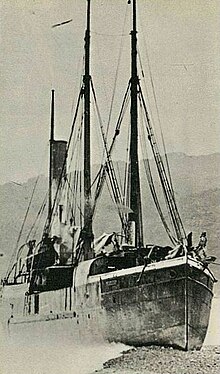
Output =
[{"x1": 48, "y1": 90, "x2": 54, "y2": 221}]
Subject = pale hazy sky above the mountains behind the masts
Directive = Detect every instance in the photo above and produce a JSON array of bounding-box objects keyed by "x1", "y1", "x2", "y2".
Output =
[{"x1": 0, "y1": 0, "x2": 220, "y2": 183}]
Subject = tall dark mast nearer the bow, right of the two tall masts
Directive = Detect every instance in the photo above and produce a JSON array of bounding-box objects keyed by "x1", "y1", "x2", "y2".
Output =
[{"x1": 129, "y1": 0, "x2": 143, "y2": 247}]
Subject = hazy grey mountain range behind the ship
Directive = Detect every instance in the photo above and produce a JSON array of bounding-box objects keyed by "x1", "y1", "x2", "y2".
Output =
[{"x1": 0, "y1": 153, "x2": 220, "y2": 293}]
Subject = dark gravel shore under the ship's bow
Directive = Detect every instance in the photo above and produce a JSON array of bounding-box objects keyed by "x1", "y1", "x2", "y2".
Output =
[{"x1": 93, "y1": 345, "x2": 220, "y2": 374}]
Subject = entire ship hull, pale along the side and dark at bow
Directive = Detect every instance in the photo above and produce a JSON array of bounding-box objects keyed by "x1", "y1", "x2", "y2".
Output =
[{"x1": 1, "y1": 258, "x2": 213, "y2": 350}]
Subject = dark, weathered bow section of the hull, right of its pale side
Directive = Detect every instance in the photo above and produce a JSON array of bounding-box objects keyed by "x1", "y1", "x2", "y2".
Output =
[{"x1": 99, "y1": 265, "x2": 212, "y2": 350}]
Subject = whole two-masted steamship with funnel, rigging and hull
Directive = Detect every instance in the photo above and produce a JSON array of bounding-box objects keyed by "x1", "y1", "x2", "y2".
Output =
[{"x1": 1, "y1": 0, "x2": 215, "y2": 350}]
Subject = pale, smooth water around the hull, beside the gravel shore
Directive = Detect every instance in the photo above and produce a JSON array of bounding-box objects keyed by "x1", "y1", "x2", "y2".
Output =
[{"x1": 0, "y1": 298, "x2": 220, "y2": 374}]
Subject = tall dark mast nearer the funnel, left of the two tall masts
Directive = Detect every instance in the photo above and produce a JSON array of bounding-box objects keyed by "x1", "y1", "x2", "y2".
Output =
[{"x1": 83, "y1": 0, "x2": 93, "y2": 260}]
